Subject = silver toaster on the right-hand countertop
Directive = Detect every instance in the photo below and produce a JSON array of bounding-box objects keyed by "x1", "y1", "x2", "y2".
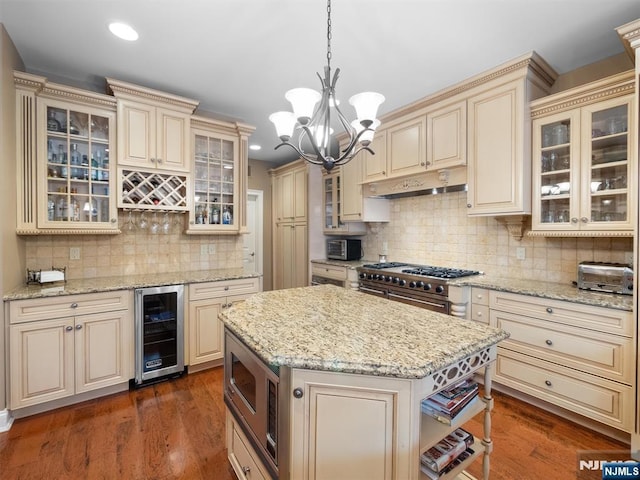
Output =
[{"x1": 578, "y1": 262, "x2": 633, "y2": 295}]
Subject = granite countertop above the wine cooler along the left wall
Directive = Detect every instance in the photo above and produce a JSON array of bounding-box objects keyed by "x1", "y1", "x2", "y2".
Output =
[{"x1": 2, "y1": 268, "x2": 260, "y2": 302}]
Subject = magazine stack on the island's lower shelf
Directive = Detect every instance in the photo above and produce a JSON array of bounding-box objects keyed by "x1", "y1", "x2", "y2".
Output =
[{"x1": 420, "y1": 428, "x2": 474, "y2": 480}]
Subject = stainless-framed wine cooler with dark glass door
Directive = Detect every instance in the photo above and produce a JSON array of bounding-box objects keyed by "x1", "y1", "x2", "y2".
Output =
[{"x1": 135, "y1": 285, "x2": 184, "y2": 386}]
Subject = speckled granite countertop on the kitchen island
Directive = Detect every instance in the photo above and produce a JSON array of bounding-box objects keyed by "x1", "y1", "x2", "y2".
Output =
[{"x1": 220, "y1": 285, "x2": 509, "y2": 379}]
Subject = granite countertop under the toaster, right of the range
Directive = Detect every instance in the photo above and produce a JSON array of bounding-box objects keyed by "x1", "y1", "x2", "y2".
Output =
[{"x1": 451, "y1": 275, "x2": 633, "y2": 312}]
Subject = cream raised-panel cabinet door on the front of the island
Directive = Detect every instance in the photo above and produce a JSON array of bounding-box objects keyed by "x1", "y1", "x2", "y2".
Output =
[{"x1": 288, "y1": 369, "x2": 416, "y2": 480}]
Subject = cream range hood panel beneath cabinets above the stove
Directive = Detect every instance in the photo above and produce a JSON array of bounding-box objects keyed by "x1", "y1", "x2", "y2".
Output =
[{"x1": 362, "y1": 167, "x2": 467, "y2": 198}]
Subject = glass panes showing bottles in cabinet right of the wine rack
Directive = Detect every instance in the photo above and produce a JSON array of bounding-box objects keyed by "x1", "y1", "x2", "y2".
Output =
[{"x1": 194, "y1": 135, "x2": 236, "y2": 225}]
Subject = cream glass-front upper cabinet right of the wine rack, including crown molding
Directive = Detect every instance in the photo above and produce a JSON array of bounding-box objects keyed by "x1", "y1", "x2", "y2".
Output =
[{"x1": 187, "y1": 117, "x2": 253, "y2": 234}]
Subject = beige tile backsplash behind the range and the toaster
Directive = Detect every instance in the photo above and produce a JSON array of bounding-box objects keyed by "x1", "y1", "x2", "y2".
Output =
[{"x1": 363, "y1": 192, "x2": 633, "y2": 283}]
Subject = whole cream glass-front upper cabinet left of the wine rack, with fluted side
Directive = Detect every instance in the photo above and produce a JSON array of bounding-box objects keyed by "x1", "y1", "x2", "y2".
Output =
[{"x1": 14, "y1": 72, "x2": 119, "y2": 235}]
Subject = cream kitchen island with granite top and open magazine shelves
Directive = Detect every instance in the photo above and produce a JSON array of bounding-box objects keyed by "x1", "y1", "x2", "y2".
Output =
[{"x1": 220, "y1": 285, "x2": 508, "y2": 480}]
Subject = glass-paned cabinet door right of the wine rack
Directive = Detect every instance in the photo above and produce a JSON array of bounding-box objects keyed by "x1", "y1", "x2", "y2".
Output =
[{"x1": 187, "y1": 128, "x2": 239, "y2": 233}]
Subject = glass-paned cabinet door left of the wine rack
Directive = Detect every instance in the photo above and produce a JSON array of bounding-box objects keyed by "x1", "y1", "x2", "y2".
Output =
[{"x1": 37, "y1": 99, "x2": 118, "y2": 231}]
